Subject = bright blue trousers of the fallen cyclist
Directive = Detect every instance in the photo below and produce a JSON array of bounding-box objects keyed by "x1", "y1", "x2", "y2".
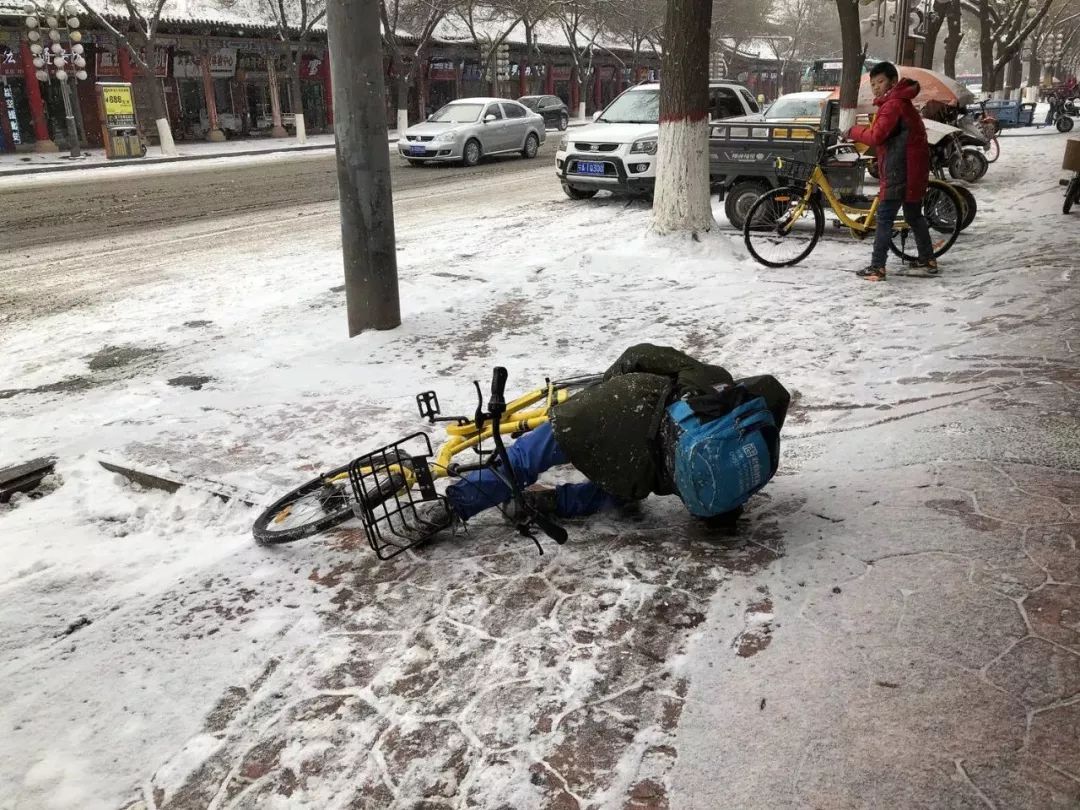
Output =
[{"x1": 446, "y1": 422, "x2": 625, "y2": 519}]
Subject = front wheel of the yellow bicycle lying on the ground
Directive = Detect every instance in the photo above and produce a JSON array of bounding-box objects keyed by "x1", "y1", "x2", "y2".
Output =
[{"x1": 252, "y1": 457, "x2": 405, "y2": 545}]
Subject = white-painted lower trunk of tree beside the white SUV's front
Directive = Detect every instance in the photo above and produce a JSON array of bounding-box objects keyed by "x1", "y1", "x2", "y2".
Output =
[{"x1": 652, "y1": 119, "x2": 713, "y2": 233}]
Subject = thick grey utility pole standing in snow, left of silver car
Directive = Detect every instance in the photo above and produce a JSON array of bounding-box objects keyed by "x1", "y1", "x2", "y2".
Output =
[{"x1": 326, "y1": 0, "x2": 402, "y2": 337}]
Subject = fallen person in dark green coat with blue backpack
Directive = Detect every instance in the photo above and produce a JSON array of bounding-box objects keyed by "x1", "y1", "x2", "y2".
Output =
[{"x1": 408, "y1": 343, "x2": 791, "y2": 534}]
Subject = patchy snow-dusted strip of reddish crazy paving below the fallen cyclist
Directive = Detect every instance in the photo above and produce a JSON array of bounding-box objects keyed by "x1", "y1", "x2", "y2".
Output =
[{"x1": 130, "y1": 504, "x2": 797, "y2": 810}]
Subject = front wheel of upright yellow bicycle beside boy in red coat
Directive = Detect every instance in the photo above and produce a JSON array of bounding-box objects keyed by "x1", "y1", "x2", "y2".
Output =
[{"x1": 743, "y1": 186, "x2": 825, "y2": 267}]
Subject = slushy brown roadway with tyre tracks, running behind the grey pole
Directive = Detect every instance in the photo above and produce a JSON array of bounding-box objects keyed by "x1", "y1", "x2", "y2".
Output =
[{"x1": 0, "y1": 144, "x2": 563, "y2": 324}]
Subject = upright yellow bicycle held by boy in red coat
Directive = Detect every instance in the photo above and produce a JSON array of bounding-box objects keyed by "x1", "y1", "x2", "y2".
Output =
[{"x1": 743, "y1": 133, "x2": 964, "y2": 267}]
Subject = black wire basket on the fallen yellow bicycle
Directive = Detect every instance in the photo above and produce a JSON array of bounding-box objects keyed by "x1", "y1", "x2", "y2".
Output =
[{"x1": 349, "y1": 433, "x2": 449, "y2": 559}]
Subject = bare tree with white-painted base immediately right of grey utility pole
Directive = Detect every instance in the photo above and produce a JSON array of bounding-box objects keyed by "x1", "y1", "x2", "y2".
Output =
[{"x1": 379, "y1": 0, "x2": 455, "y2": 132}]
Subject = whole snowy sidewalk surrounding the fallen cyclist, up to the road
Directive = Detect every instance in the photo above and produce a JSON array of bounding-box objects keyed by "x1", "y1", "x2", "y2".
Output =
[{"x1": 0, "y1": 134, "x2": 1080, "y2": 810}]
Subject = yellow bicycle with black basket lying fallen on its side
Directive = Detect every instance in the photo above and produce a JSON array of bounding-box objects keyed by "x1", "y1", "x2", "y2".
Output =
[{"x1": 252, "y1": 367, "x2": 602, "y2": 559}]
